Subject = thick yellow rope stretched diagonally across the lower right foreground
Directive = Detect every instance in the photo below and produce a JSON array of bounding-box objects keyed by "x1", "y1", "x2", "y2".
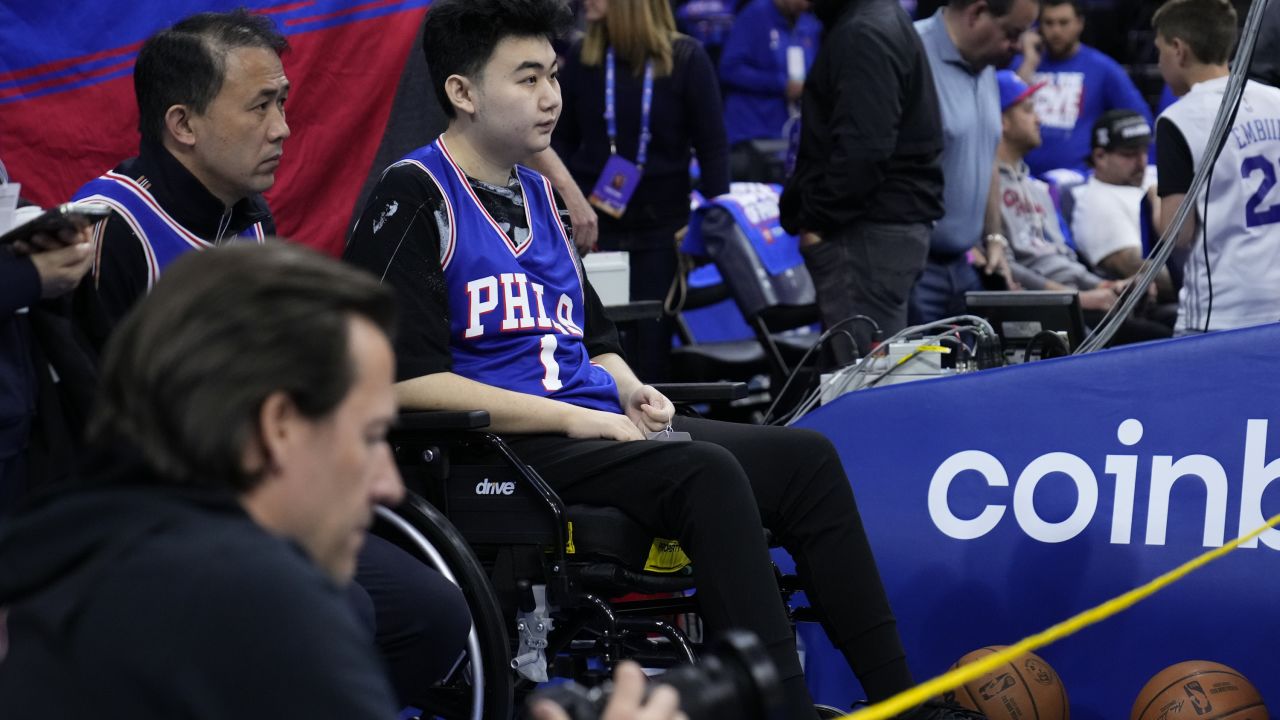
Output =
[{"x1": 840, "y1": 515, "x2": 1280, "y2": 720}]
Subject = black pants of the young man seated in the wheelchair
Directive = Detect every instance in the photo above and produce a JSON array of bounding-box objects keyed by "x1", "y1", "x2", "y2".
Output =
[{"x1": 507, "y1": 418, "x2": 911, "y2": 717}]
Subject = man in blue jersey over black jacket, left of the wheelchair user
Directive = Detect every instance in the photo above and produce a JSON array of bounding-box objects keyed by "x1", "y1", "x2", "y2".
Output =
[{"x1": 76, "y1": 10, "x2": 289, "y2": 347}]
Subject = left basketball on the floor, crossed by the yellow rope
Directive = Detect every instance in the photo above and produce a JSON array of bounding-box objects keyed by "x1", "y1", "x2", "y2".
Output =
[{"x1": 942, "y1": 646, "x2": 1071, "y2": 720}]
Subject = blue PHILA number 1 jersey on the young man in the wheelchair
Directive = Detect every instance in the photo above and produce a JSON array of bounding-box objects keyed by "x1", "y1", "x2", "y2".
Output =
[{"x1": 397, "y1": 138, "x2": 621, "y2": 413}]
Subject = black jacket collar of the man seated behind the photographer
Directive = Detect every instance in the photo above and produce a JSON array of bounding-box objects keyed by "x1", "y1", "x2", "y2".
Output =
[{"x1": 115, "y1": 140, "x2": 275, "y2": 242}]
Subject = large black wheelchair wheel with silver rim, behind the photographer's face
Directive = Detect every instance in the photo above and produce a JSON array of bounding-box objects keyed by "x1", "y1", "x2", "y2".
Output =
[{"x1": 378, "y1": 493, "x2": 515, "y2": 720}]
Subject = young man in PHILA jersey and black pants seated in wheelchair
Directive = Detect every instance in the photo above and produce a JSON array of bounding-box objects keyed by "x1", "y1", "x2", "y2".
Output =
[{"x1": 344, "y1": 0, "x2": 972, "y2": 717}]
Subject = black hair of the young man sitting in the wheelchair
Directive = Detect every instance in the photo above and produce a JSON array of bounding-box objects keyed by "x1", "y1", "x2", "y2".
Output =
[{"x1": 422, "y1": 0, "x2": 573, "y2": 119}]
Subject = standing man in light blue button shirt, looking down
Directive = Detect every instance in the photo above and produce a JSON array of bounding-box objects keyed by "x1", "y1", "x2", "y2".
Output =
[{"x1": 910, "y1": 0, "x2": 1037, "y2": 323}]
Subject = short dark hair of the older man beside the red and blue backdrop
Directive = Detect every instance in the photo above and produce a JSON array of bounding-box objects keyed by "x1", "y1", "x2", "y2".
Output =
[{"x1": 133, "y1": 8, "x2": 289, "y2": 142}]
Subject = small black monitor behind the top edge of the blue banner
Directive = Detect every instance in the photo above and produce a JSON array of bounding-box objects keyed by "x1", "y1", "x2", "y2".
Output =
[{"x1": 965, "y1": 290, "x2": 1085, "y2": 364}]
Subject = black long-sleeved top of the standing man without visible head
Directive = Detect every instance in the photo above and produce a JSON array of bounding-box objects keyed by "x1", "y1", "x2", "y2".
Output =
[{"x1": 781, "y1": 0, "x2": 943, "y2": 233}]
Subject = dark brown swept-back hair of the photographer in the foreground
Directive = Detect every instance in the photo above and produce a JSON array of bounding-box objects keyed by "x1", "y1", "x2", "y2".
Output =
[{"x1": 88, "y1": 241, "x2": 394, "y2": 493}]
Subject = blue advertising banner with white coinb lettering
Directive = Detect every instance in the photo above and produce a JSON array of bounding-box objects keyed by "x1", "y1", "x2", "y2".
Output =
[{"x1": 799, "y1": 325, "x2": 1280, "y2": 720}]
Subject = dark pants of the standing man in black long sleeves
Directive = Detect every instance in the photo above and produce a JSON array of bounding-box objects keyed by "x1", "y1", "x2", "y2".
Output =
[{"x1": 800, "y1": 222, "x2": 931, "y2": 365}]
